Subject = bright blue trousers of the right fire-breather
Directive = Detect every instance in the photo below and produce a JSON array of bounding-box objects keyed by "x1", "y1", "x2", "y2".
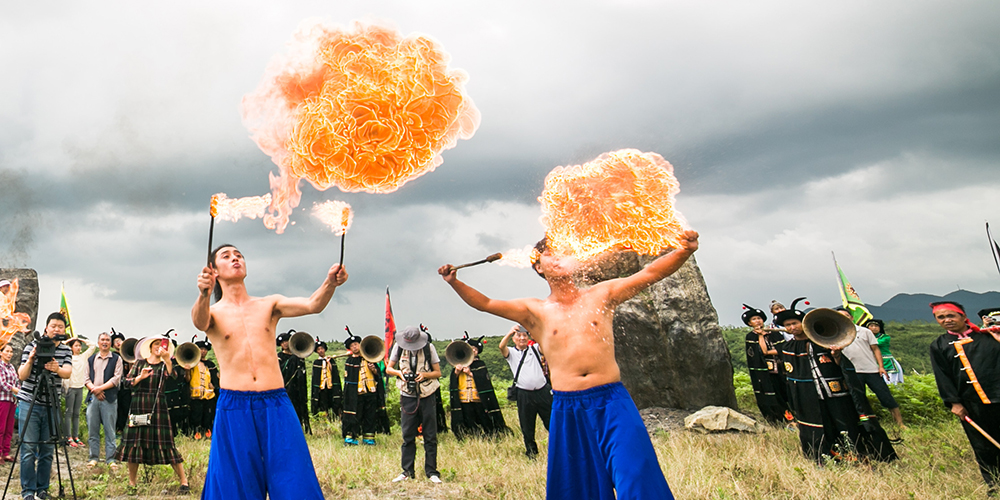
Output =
[{"x1": 545, "y1": 382, "x2": 673, "y2": 500}]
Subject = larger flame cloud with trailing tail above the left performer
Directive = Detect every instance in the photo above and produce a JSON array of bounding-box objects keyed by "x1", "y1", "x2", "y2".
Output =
[{"x1": 242, "y1": 22, "x2": 480, "y2": 233}]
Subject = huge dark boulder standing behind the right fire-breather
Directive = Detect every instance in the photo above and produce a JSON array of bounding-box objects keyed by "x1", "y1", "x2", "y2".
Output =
[{"x1": 579, "y1": 252, "x2": 737, "y2": 410}]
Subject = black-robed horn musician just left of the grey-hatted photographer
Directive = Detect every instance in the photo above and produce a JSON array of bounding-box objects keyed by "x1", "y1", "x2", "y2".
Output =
[{"x1": 340, "y1": 335, "x2": 389, "y2": 446}]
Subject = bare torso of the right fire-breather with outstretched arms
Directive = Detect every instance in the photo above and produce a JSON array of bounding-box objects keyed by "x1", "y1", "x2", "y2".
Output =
[{"x1": 524, "y1": 285, "x2": 621, "y2": 391}]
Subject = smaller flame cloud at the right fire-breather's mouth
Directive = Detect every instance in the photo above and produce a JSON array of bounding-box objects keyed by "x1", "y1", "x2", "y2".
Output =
[{"x1": 539, "y1": 149, "x2": 687, "y2": 260}]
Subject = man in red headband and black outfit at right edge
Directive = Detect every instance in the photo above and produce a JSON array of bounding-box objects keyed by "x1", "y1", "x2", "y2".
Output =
[{"x1": 930, "y1": 302, "x2": 1000, "y2": 496}]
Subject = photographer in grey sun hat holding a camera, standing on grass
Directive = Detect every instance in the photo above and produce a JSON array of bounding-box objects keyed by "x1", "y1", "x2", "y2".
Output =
[{"x1": 385, "y1": 326, "x2": 441, "y2": 483}]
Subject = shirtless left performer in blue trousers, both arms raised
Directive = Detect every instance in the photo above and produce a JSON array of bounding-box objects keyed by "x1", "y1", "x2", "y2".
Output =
[{"x1": 191, "y1": 245, "x2": 347, "y2": 500}]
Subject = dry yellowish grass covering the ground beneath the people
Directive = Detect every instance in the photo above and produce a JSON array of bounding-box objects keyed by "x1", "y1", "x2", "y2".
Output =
[{"x1": 27, "y1": 408, "x2": 985, "y2": 500}]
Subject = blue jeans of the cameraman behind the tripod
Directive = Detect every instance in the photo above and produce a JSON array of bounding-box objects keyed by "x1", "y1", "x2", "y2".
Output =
[{"x1": 17, "y1": 401, "x2": 59, "y2": 497}]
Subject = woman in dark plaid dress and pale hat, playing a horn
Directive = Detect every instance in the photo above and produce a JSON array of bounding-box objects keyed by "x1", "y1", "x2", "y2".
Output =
[{"x1": 117, "y1": 339, "x2": 191, "y2": 493}]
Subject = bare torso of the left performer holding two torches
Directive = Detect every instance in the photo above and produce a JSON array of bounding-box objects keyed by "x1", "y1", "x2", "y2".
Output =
[{"x1": 206, "y1": 295, "x2": 285, "y2": 392}]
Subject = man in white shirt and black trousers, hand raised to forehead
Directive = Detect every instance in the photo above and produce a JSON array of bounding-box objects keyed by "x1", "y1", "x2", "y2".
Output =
[{"x1": 500, "y1": 325, "x2": 552, "y2": 459}]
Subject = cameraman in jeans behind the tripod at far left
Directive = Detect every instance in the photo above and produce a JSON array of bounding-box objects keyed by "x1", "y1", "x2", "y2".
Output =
[{"x1": 17, "y1": 312, "x2": 73, "y2": 499}]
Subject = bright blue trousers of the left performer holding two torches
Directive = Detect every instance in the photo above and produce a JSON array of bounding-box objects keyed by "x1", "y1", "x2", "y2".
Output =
[{"x1": 201, "y1": 389, "x2": 323, "y2": 500}]
